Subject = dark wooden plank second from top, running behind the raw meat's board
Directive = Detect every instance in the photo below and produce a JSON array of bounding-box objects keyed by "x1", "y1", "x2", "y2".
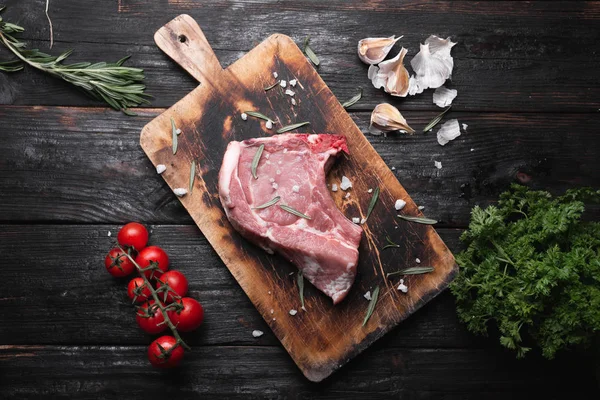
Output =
[{"x1": 0, "y1": 106, "x2": 600, "y2": 227}]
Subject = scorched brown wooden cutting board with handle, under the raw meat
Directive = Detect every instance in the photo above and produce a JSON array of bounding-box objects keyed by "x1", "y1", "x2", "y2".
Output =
[{"x1": 140, "y1": 15, "x2": 457, "y2": 382}]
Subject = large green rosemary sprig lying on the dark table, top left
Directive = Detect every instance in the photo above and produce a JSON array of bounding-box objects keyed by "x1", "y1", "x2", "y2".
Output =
[{"x1": 0, "y1": 8, "x2": 151, "y2": 115}]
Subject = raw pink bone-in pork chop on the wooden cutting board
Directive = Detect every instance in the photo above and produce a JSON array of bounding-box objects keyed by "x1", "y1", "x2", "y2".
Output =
[{"x1": 219, "y1": 134, "x2": 362, "y2": 304}]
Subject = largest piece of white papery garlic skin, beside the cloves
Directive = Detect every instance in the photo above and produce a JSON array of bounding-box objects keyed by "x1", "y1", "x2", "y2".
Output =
[{"x1": 409, "y1": 35, "x2": 456, "y2": 94}]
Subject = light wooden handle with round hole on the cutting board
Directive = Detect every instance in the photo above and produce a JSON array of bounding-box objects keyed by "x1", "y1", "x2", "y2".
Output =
[{"x1": 154, "y1": 14, "x2": 223, "y2": 84}]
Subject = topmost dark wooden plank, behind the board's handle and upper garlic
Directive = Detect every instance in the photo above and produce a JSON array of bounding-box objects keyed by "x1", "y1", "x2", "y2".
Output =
[{"x1": 0, "y1": 0, "x2": 600, "y2": 112}]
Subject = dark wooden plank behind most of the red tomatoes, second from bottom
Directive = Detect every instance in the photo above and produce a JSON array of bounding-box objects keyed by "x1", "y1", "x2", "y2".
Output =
[{"x1": 0, "y1": 225, "x2": 478, "y2": 348}]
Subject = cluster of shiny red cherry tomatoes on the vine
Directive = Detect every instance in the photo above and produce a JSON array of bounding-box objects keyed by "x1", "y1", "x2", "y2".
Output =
[{"x1": 104, "y1": 222, "x2": 204, "y2": 368}]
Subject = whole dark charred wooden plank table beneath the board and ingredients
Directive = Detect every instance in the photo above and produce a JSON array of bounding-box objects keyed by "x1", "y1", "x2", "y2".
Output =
[{"x1": 0, "y1": 0, "x2": 600, "y2": 400}]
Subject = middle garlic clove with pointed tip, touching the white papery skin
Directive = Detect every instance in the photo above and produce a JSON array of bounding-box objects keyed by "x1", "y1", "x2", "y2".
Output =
[{"x1": 368, "y1": 47, "x2": 409, "y2": 97}]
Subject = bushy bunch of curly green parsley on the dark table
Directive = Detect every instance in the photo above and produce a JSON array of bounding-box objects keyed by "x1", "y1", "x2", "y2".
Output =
[{"x1": 450, "y1": 185, "x2": 600, "y2": 358}]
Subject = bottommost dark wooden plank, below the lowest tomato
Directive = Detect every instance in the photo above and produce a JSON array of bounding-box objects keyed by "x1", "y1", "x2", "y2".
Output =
[{"x1": 0, "y1": 346, "x2": 600, "y2": 400}]
